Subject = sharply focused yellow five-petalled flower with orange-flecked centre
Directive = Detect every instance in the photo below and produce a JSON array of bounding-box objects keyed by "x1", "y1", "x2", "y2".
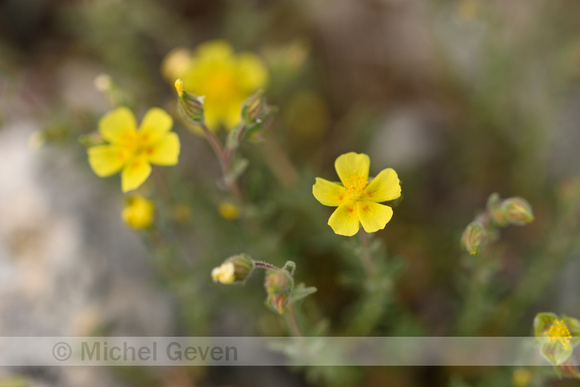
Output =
[{"x1": 312, "y1": 152, "x2": 401, "y2": 236}]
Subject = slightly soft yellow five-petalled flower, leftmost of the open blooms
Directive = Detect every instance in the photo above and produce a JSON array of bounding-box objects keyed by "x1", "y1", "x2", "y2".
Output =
[{"x1": 88, "y1": 107, "x2": 180, "y2": 192}]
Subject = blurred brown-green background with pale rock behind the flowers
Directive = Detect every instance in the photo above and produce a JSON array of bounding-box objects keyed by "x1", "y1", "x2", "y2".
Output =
[{"x1": 0, "y1": 0, "x2": 580, "y2": 387}]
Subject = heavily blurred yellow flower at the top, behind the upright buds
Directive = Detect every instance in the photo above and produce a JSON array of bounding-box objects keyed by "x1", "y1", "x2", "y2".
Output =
[{"x1": 166, "y1": 40, "x2": 268, "y2": 130}]
